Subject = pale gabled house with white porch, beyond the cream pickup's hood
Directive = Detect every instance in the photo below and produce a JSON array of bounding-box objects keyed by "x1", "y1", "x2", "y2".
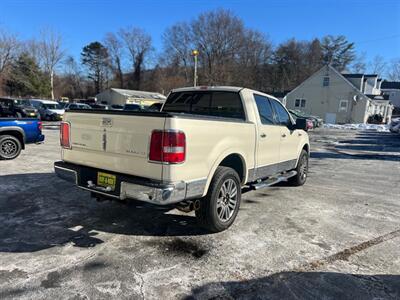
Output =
[{"x1": 284, "y1": 65, "x2": 393, "y2": 124}]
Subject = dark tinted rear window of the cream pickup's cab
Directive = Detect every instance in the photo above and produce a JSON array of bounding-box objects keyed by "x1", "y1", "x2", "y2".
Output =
[{"x1": 162, "y1": 91, "x2": 245, "y2": 120}]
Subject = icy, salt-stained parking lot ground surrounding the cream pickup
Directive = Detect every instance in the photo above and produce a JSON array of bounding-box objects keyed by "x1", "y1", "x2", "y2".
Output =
[{"x1": 0, "y1": 127, "x2": 400, "y2": 299}]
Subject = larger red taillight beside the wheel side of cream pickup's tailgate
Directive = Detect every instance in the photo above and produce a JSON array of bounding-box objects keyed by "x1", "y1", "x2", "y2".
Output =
[{"x1": 149, "y1": 130, "x2": 186, "y2": 164}]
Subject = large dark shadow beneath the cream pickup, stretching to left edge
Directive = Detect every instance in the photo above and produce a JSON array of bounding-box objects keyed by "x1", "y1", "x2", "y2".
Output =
[{"x1": 0, "y1": 173, "x2": 207, "y2": 252}]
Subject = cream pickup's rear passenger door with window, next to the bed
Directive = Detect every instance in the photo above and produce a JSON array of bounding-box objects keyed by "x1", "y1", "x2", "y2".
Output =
[{"x1": 254, "y1": 94, "x2": 281, "y2": 178}]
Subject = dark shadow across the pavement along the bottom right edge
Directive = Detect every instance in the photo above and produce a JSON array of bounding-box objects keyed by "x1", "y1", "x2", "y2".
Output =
[{"x1": 185, "y1": 272, "x2": 400, "y2": 300}]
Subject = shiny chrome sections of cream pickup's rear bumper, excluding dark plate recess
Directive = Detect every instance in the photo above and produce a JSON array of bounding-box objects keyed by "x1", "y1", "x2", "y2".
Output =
[{"x1": 54, "y1": 164, "x2": 206, "y2": 205}]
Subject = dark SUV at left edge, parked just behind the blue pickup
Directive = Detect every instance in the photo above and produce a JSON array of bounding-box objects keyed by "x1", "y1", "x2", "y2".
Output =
[{"x1": 0, "y1": 98, "x2": 39, "y2": 118}]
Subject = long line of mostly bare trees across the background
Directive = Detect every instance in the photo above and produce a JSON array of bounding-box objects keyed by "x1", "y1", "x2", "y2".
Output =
[{"x1": 0, "y1": 9, "x2": 400, "y2": 99}]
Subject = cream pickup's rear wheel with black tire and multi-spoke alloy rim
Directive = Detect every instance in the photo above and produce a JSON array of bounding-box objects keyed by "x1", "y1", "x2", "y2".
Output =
[{"x1": 195, "y1": 167, "x2": 242, "y2": 232}]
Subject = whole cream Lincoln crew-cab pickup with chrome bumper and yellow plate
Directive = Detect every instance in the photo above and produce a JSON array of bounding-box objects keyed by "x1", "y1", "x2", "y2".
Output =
[{"x1": 54, "y1": 87, "x2": 310, "y2": 232}]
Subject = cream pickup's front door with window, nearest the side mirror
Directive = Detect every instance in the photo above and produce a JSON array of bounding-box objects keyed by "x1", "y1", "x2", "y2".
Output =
[{"x1": 270, "y1": 99, "x2": 300, "y2": 171}]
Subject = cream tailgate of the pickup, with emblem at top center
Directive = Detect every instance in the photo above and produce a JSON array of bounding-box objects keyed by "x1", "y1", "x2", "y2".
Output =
[{"x1": 63, "y1": 112, "x2": 166, "y2": 180}]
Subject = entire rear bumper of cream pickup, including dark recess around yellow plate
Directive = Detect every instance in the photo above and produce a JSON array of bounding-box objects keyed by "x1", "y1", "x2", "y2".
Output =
[{"x1": 54, "y1": 161, "x2": 206, "y2": 205}]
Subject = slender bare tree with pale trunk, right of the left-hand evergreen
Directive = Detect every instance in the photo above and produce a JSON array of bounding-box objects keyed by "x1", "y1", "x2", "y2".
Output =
[{"x1": 39, "y1": 29, "x2": 65, "y2": 99}]
